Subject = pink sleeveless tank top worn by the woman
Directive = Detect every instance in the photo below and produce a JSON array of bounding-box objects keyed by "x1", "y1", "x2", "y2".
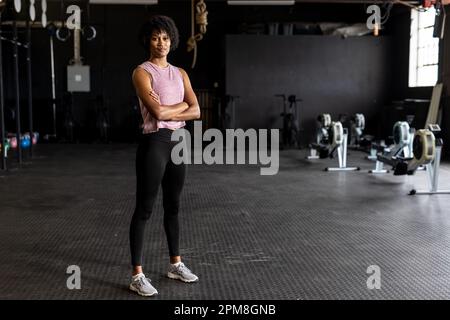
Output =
[{"x1": 138, "y1": 61, "x2": 186, "y2": 134}]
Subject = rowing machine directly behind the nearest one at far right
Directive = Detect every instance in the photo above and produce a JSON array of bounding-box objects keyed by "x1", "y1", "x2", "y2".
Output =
[{"x1": 369, "y1": 121, "x2": 415, "y2": 175}]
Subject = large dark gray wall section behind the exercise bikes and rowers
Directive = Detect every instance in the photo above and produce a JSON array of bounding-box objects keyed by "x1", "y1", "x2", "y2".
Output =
[{"x1": 226, "y1": 35, "x2": 391, "y2": 144}]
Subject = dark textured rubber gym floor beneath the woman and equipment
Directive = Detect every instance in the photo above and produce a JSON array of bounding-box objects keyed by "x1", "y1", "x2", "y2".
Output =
[{"x1": 0, "y1": 144, "x2": 450, "y2": 300}]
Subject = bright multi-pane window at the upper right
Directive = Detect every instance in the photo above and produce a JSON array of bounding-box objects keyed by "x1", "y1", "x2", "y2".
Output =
[{"x1": 409, "y1": 7, "x2": 439, "y2": 87}]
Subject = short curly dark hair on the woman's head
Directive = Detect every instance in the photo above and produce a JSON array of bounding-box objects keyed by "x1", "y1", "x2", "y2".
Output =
[{"x1": 139, "y1": 15, "x2": 180, "y2": 51}]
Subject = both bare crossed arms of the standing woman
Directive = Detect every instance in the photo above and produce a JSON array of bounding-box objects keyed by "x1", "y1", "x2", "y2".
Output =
[{"x1": 133, "y1": 68, "x2": 200, "y2": 121}]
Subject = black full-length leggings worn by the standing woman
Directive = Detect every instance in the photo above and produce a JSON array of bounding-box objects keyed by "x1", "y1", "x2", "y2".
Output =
[{"x1": 130, "y1": 129, "x2": 186, "y2": 266}]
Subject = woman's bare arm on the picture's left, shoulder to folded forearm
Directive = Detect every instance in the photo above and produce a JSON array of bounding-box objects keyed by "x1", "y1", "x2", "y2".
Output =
[{"x1": 133, "y1": 68, "x2": 189, "y2": 121}]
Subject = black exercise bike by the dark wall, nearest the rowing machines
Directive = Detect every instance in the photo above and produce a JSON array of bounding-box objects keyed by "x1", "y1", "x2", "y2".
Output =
[{"x1": 275, "y1": 94, "x2": 302, "y2": 149}]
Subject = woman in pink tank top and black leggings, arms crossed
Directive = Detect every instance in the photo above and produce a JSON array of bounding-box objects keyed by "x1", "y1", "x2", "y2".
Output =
[{"x1": 130, "y1": 16, "x2": 200, "y2": 296}]
